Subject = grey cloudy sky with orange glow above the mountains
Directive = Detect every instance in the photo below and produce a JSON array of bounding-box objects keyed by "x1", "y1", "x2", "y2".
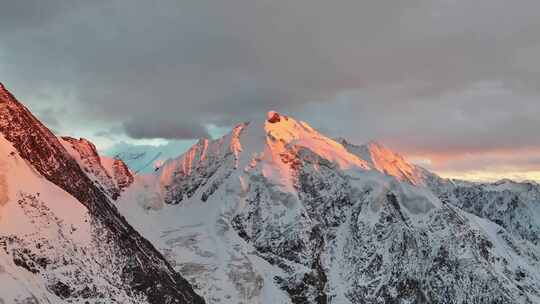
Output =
[{"x1": 0, "y1": 0, "x2": 540, "y2": 180}]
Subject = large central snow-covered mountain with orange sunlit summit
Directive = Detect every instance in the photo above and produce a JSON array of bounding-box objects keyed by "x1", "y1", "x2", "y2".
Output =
[{"x1": 116, "y1": 112, "x2": 540, "y2": 304}]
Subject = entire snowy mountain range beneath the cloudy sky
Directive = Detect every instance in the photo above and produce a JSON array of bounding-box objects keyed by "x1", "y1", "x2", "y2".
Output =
[{"x1": 0, "y1": 82, "x2": 540, "y2": 304}]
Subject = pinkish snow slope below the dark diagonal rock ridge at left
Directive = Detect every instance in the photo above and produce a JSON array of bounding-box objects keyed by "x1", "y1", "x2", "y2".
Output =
[{"x1": 0, "y1": 136, "x2": 146, "y2": 303}]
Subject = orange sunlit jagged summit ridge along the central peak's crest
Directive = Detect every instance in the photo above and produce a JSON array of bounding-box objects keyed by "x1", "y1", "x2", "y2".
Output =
[{"x1": 158, "y1": 111, "x2": 425, "y2": 196}]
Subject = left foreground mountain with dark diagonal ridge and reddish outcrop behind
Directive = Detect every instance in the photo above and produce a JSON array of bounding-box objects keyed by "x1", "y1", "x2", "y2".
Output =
[{"x1": 0, "y1": 85, "x2": 203, "y2": 304}]
